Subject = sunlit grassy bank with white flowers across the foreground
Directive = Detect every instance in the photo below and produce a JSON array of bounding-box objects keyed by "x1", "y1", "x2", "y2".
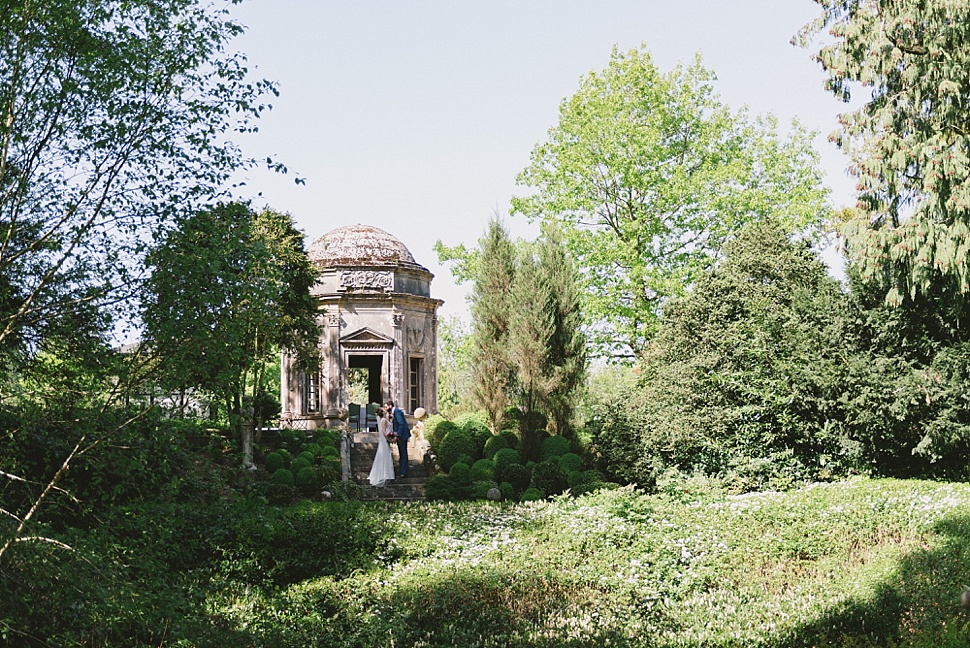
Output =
[{"x1": 2, "y1": 479, "x2": 970, "y2": 647}]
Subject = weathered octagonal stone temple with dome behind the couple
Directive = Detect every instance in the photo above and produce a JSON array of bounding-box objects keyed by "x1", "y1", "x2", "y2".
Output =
[{"x1": 280, "y1": 225, "x2": 444, "y2": 429}]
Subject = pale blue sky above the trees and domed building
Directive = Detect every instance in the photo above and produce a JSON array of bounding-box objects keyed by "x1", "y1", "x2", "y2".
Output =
[{"x1": 233, "y1": 0, "x2": 853, "y2": 315}]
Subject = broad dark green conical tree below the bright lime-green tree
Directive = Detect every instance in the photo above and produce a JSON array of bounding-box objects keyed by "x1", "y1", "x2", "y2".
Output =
[{"x1": 593, "y1": 223, "x2": 858, "y2": 486}]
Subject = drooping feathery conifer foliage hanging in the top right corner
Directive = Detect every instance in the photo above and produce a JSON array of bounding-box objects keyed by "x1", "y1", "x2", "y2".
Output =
[{"x1": 796, "y1": 0, "x2": 970, "y2": 304}]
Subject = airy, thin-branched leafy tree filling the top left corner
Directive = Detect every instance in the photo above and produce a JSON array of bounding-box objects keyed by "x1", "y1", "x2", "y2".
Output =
[{"x1": 0, "y1": 0, "x2": 275, "y2": 356}]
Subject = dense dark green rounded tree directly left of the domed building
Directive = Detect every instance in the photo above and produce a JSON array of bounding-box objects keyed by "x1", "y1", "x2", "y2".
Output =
[{"x1": 144, "y1": 202, "x2": 319, "y2": 436}]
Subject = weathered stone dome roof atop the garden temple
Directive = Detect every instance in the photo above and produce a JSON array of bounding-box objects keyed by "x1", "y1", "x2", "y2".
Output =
[{"x1": 307, "y1": 225, "x2": 421, "y2": 268}]
